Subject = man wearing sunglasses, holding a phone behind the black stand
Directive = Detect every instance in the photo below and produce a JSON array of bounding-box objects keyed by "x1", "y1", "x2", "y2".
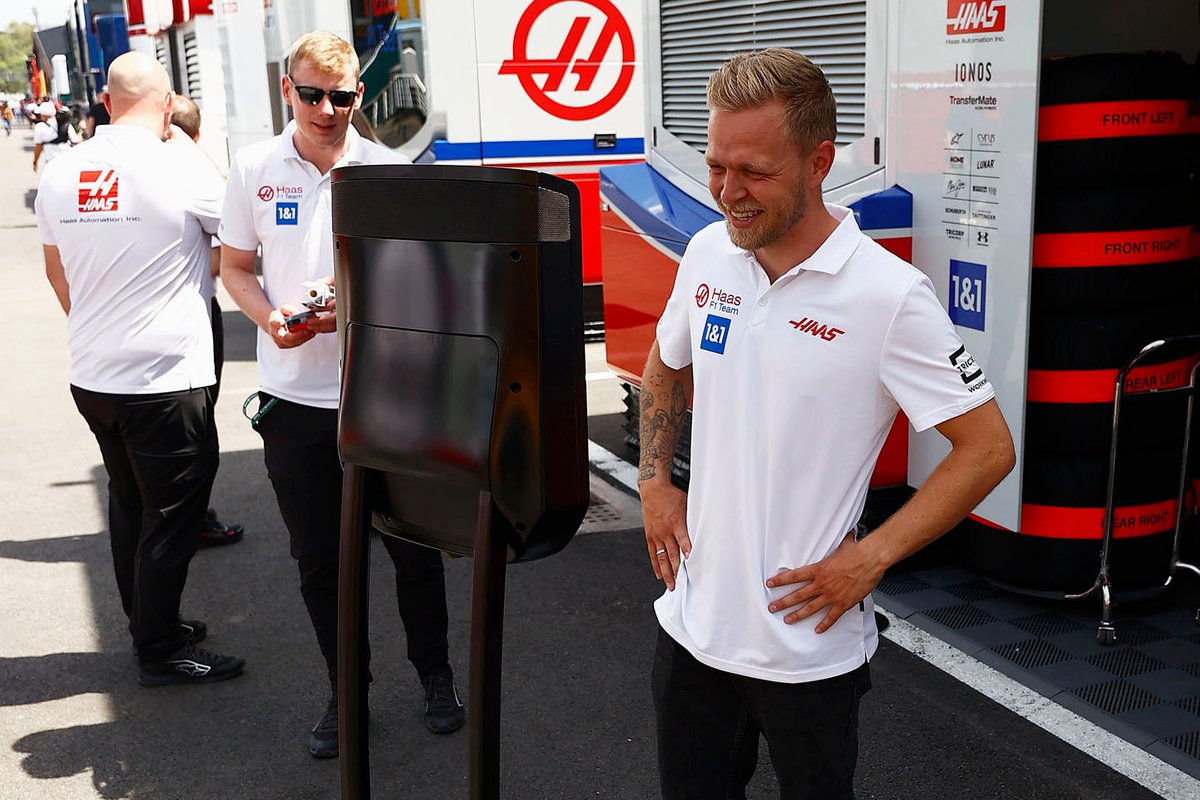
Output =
[{"x1": 218, "y1": 31, "x2": 464, "y2": 758}]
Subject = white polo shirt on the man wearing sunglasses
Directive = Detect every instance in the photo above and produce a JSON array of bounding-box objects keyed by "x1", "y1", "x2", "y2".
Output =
[{"x1": 220, "y1": 121, "x2": 409, "y2": 408}]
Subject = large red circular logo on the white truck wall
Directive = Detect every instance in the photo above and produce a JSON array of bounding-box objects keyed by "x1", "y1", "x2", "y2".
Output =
[{"x1": 499, "y1": 0, "x2": 635, "y2": 122}]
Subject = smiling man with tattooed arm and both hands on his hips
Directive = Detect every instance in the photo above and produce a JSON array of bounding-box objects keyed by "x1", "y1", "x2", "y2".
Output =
[{"x1": 638, "y1": 48, "x2": 1014, "y2": 800}]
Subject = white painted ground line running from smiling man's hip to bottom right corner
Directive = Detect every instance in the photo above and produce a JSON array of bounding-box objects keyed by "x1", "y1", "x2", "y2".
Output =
[{"x1": 876, "y1": 599, "x2": 1200, "y2": 800}]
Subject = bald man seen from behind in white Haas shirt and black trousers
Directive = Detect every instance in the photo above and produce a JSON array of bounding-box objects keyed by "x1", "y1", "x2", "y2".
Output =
[{"x1": 35, "y1": 52, "x2": 244, "y2": 686}]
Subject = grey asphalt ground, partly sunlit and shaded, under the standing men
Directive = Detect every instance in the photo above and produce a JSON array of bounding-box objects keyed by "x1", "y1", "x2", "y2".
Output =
[{"x1": 0, "y1": 127, "x2": 1196, "y2": 800}]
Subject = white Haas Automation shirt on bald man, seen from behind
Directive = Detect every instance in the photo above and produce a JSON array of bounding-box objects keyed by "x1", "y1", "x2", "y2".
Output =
[{"x1": 35, "y1": 125, "x2": 223, "y2": 395}]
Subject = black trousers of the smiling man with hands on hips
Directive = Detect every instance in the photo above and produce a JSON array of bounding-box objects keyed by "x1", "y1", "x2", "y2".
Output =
[{"x1": 650, "y1": 628, "x2": 871, "y2": 800}]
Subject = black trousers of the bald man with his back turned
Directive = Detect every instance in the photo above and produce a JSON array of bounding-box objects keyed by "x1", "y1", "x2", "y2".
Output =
[{"x1": 71, "y1": 386, "x2": 218, "y2": 662}]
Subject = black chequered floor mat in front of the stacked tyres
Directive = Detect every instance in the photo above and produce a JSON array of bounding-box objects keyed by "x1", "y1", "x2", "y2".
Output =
[{"x1": 875, "y1": 566, "x2": 1200, "y2": 778}]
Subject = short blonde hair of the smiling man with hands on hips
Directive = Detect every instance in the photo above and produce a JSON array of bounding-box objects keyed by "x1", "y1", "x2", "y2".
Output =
[{"x1": 708, "y1": 47, "x2": 838, "y2": 154}]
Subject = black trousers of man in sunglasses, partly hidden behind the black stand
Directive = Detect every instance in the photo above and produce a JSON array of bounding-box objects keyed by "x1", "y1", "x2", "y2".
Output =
[{"x1": 258, "y1": 392, "x2": 450, "y2": 681}]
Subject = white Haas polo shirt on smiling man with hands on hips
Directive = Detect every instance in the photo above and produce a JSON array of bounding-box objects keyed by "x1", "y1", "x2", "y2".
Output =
[{"x1": 654, "y1": 205, "x2": 994, "y2": 682}]
